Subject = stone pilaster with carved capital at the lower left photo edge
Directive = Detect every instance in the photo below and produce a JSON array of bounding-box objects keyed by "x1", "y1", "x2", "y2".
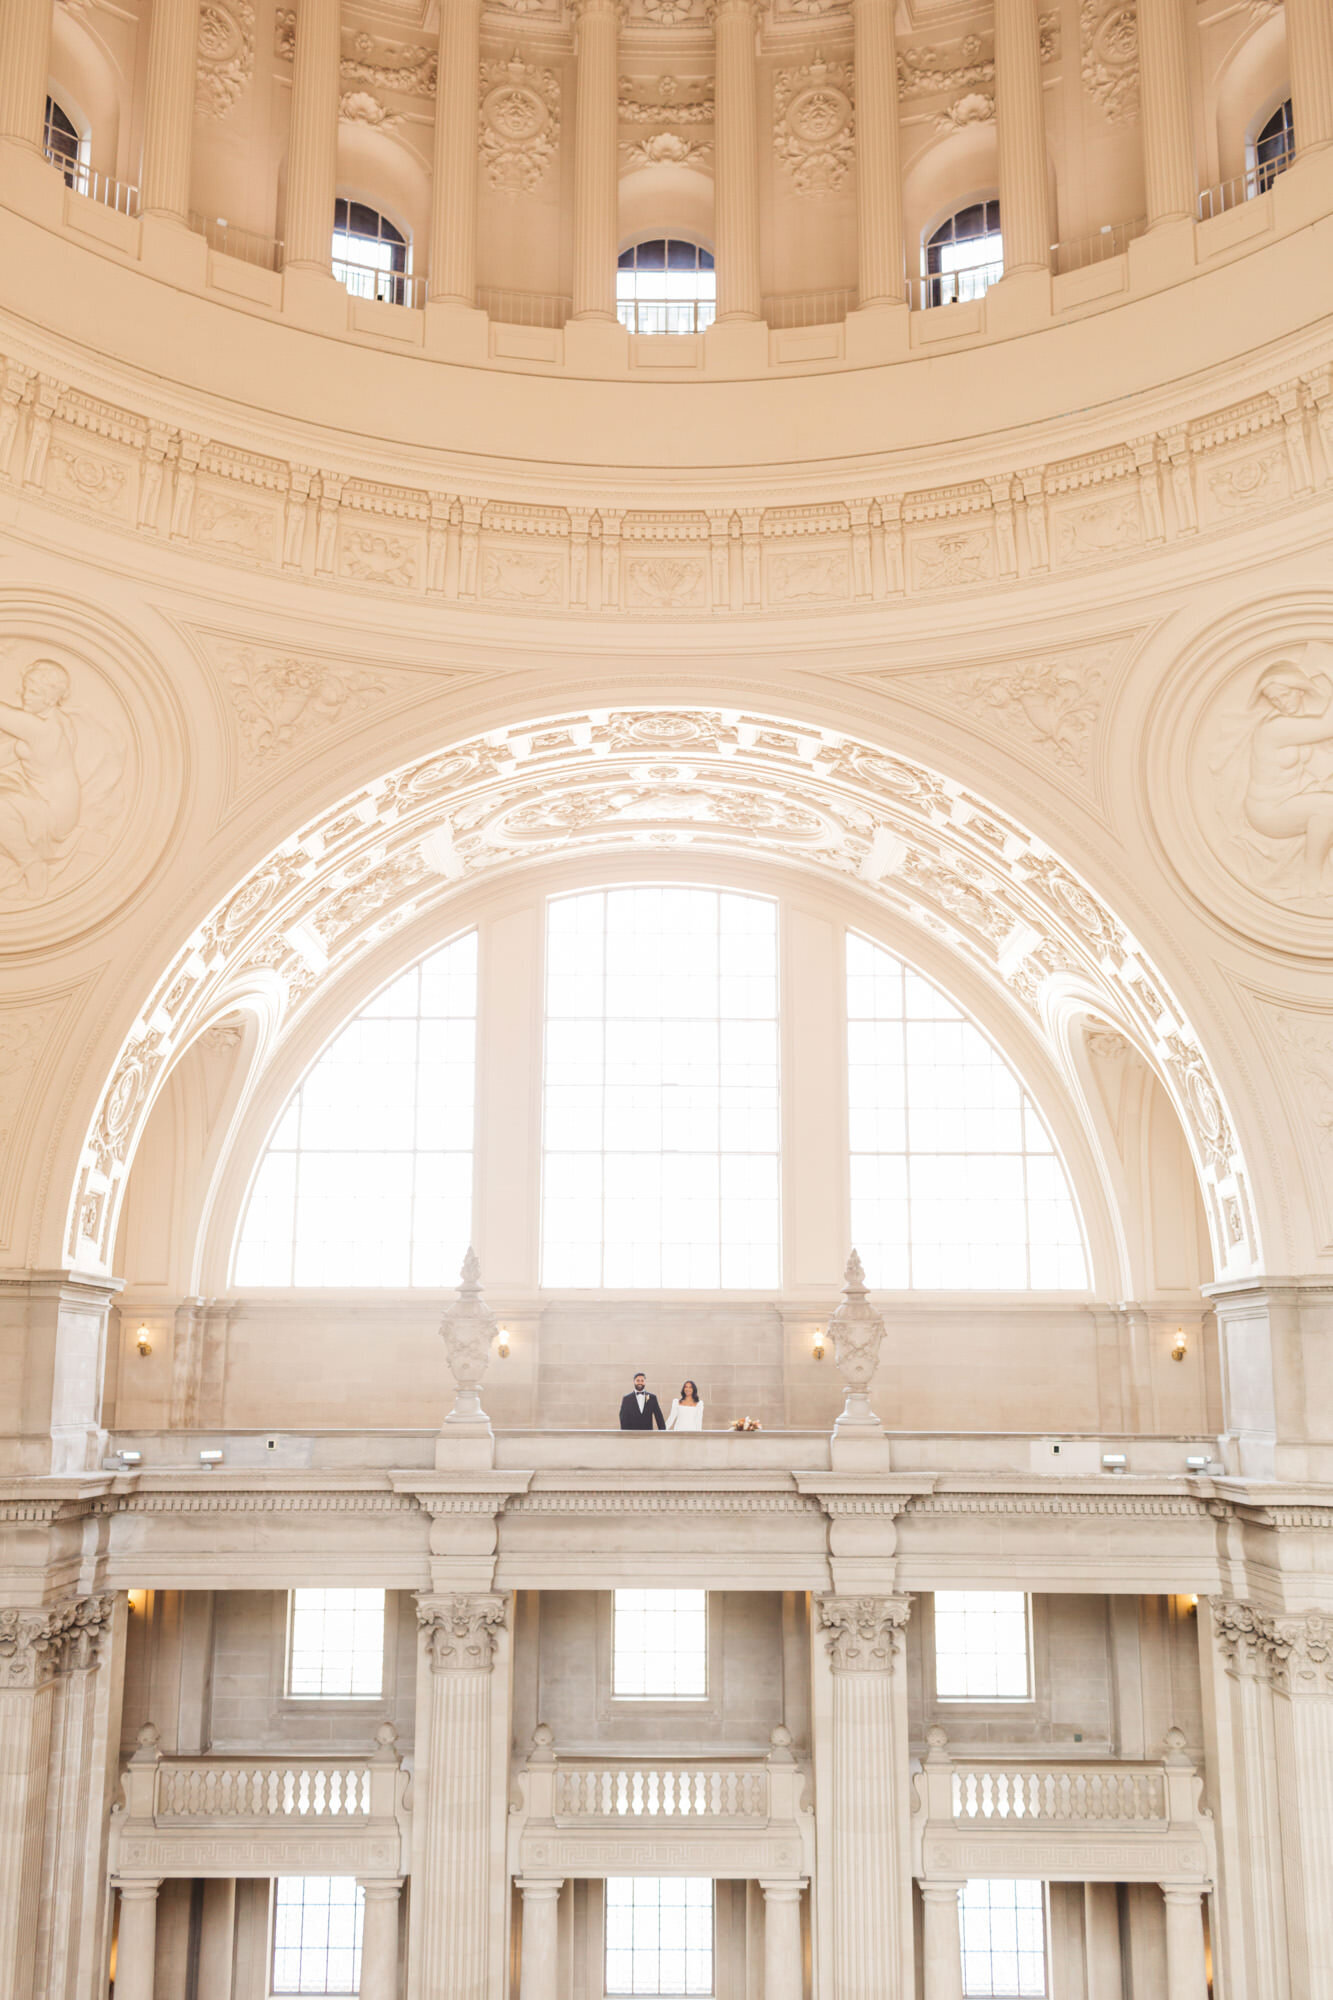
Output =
[{"x1": 0, "y1": 1596, "x2": 114, "y2": 2000}]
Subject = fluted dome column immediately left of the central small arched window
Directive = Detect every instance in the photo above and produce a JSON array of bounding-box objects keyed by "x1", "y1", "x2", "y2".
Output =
[{"x1": 574, "y1": 0, "x2": 620, "y2": 320}]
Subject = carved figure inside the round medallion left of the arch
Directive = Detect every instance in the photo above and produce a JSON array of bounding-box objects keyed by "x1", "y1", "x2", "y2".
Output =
[{"x1": 0, "y1": 660, "x2": 126, "y2": 904}]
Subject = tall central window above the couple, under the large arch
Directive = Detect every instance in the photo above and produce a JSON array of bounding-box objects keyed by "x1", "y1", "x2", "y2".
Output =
[{"x1": 542, "y1": 886, "x2": 781, "y2": 1290}]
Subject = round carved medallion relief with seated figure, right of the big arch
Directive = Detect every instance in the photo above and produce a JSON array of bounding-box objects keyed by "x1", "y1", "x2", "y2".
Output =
[{"x1": 1151, "y1": 620, "x2": 1333, "y2": 954}]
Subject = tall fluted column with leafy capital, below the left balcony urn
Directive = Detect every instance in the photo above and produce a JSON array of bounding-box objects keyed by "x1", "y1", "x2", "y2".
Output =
[{"x1": 410, "y1": 1592, "x2": 504, "y2": 2000}]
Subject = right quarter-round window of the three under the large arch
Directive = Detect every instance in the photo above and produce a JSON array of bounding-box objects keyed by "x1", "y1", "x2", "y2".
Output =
[{"x1": 847, "y1": 934, "x2": 1087, "y2": 1292}]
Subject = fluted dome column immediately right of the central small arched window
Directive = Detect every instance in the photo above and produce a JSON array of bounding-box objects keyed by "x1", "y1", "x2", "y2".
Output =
[{"x1": 713, "y1": 0, "x2": 759, "y2": 320}]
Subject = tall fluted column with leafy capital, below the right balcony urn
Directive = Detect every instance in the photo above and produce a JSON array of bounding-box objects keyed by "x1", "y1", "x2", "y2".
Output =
[{"x1": 815, "y1": 1596, "x2": 913, "y2": 2000}]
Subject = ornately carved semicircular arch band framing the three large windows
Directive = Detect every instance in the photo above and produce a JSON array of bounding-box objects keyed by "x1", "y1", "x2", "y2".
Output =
[{"x1": 66, "y1": 706, "x2": 1259, "y2": 1272}]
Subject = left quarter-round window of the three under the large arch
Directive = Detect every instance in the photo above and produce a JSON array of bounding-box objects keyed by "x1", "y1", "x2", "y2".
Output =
[{"x1": 234, "y1": 932, "x2": 476, "y2": 1286}]
